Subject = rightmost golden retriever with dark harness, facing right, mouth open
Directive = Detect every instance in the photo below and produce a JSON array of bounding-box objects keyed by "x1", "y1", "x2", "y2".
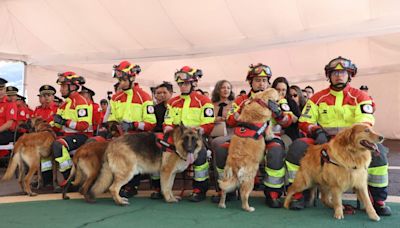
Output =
[{"x1": 284, "y1": 124, "x2": 383, "y2": 221}]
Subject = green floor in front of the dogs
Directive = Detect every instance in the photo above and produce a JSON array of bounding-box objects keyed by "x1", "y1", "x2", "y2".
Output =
[{"x1": 0, "y1": 198, "x2": 400, "y2": 228}]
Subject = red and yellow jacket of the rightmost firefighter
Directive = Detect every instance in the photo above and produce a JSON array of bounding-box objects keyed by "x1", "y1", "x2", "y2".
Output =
[{"x1": 299, "y1": 85, "x2": 375, "y2": 135}]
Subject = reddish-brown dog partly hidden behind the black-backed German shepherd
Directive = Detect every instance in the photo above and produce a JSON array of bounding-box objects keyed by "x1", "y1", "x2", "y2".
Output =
[{"x1": 62, "y1": 121, "x2": 122, "y2": 202}]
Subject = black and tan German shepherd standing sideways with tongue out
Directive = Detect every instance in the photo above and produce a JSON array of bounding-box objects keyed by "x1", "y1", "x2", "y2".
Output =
[{"x1": 90, "y1": 126, "x2": 203, "y2": 205}]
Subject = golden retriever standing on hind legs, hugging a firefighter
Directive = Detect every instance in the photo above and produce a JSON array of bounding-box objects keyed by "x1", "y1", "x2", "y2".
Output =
[{"x1": 218, "y1": 88, "x2": 279, "y2": 212}]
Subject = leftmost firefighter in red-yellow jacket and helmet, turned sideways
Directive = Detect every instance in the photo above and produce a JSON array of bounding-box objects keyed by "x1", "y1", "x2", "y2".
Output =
[{"x1": 50, "y1": 72, "x2": 93, "y2": 183}]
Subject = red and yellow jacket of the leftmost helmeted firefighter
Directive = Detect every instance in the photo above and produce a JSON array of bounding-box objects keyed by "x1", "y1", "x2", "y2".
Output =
[{"x1": 51, "y1": 92, "x2": 93, "y2": 136}]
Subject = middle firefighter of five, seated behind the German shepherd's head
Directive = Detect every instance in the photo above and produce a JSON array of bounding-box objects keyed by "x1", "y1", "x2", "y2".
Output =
[{"x1": 163, "y1": 66, "x2": 215, "y2": 202}]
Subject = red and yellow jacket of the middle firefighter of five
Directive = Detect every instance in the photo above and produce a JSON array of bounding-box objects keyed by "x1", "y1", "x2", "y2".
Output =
[{"x1": 163, "y1": 92, "x2": 215, "y2": 135}]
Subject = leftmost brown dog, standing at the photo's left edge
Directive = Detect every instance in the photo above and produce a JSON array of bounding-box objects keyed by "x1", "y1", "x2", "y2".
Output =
[{"x1": 2, "y1": 118, "x2": 57, "y2": 196}]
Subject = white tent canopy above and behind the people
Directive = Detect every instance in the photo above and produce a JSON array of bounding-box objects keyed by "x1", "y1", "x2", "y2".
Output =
[{"x1": 0, "y1": 0, "x2": 400, "y2": 138}]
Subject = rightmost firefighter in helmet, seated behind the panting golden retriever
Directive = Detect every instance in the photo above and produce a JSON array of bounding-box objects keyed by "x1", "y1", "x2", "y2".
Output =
[{"x1": 286, "y1": 56, "x2": 391, "y2": 216}]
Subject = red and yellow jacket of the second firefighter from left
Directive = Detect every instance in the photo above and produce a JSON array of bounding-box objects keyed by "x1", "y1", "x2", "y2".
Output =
[{"x1": 108, "y1": 85, "x2": 156, "y2": 131}]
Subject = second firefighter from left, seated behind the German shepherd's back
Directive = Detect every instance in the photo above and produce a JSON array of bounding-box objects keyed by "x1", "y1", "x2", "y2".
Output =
[{"x1": 108, "y1": 61, "x2": 156, "y2": 197}]
